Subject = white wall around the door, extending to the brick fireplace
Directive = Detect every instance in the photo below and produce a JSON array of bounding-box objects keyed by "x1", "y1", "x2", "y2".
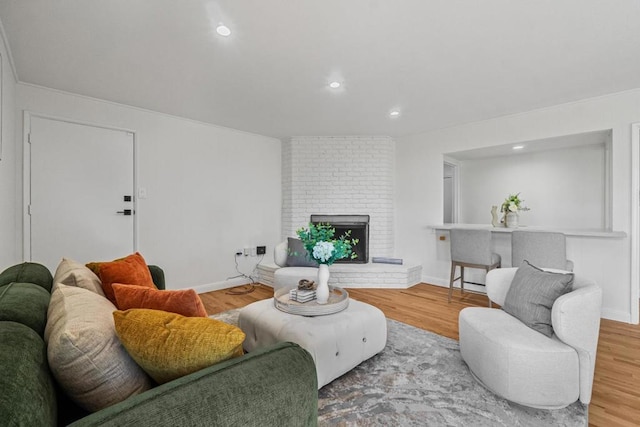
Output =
[{"x1": 9, "y1": 84, "x2": 281, "y2": 291}]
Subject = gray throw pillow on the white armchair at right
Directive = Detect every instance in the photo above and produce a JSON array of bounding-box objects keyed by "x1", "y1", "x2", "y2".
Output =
[{"x1": 502, "y1": 261, "x2": 573, "y2": 337}]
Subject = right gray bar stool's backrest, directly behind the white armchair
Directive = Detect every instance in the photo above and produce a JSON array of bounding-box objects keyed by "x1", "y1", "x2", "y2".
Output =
[{"x1": 511, "y1": 230, "x2": 573, "y2": 271}]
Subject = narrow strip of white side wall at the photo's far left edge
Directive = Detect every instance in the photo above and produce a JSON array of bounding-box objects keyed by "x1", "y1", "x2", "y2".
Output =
[{"x1": 0, "y1": 29, "x2": 20, "y2": 271}]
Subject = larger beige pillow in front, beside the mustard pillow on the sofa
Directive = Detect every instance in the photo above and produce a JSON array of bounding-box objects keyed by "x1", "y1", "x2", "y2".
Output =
[{"x1": 45, "y1": 284, "x2": 152, "y2": 411}]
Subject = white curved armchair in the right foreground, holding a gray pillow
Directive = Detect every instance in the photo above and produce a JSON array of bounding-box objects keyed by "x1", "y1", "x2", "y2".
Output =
[{"x1": 459, "y1": 268, "x2": 602, "y2": 409}]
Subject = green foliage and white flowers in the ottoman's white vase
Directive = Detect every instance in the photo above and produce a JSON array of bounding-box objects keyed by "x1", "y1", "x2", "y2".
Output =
[{"x1": 296, "y1": 223, "x2": 358, "y2": 265}]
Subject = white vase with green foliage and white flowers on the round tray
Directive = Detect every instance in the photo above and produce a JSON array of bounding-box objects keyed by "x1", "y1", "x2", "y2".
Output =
[{"x1": 296, "y1": 223, "x2": 358, "y2": 304}]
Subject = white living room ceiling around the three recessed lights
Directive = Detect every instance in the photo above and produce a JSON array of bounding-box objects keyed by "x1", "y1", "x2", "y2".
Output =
[{"x1": 0, "y1": 0, "x2": 640, "y2": 137}]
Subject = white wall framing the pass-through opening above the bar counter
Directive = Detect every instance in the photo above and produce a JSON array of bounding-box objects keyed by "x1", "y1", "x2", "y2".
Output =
[{"x1": 396, "y1": 90, "x2": 640, "y2": 321}]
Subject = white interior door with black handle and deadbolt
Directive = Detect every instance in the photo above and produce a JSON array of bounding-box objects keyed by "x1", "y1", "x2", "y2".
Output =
[{"x1": 26, "y1": 116, "x2": 135, "y2": 271}]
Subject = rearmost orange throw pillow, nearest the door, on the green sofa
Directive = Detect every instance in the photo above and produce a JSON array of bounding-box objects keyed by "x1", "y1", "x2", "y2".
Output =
[{"x1": 87, "y1": 252, "x2": 157, "y2": 304}]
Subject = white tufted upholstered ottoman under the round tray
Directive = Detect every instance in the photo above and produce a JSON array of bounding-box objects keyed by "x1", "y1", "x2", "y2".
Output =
[{"x1": 238, "y1": 298, "x2": 387, "y2": 388}]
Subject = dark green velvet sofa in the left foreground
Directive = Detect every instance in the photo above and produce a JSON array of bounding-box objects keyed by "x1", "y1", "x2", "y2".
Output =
[{"x1": 0, "y1": 263, "x2": 318, "y2": 427}]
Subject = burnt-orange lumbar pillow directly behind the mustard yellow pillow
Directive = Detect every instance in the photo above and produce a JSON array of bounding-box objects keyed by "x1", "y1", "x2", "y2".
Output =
[{"x1": 112, "y1": 283, "x2": 207, "y2": 317}]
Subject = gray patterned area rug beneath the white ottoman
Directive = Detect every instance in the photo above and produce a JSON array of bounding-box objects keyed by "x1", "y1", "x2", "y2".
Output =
[{"x1": 211, "y1": 310, "x2": 588, "y2": 426}]
